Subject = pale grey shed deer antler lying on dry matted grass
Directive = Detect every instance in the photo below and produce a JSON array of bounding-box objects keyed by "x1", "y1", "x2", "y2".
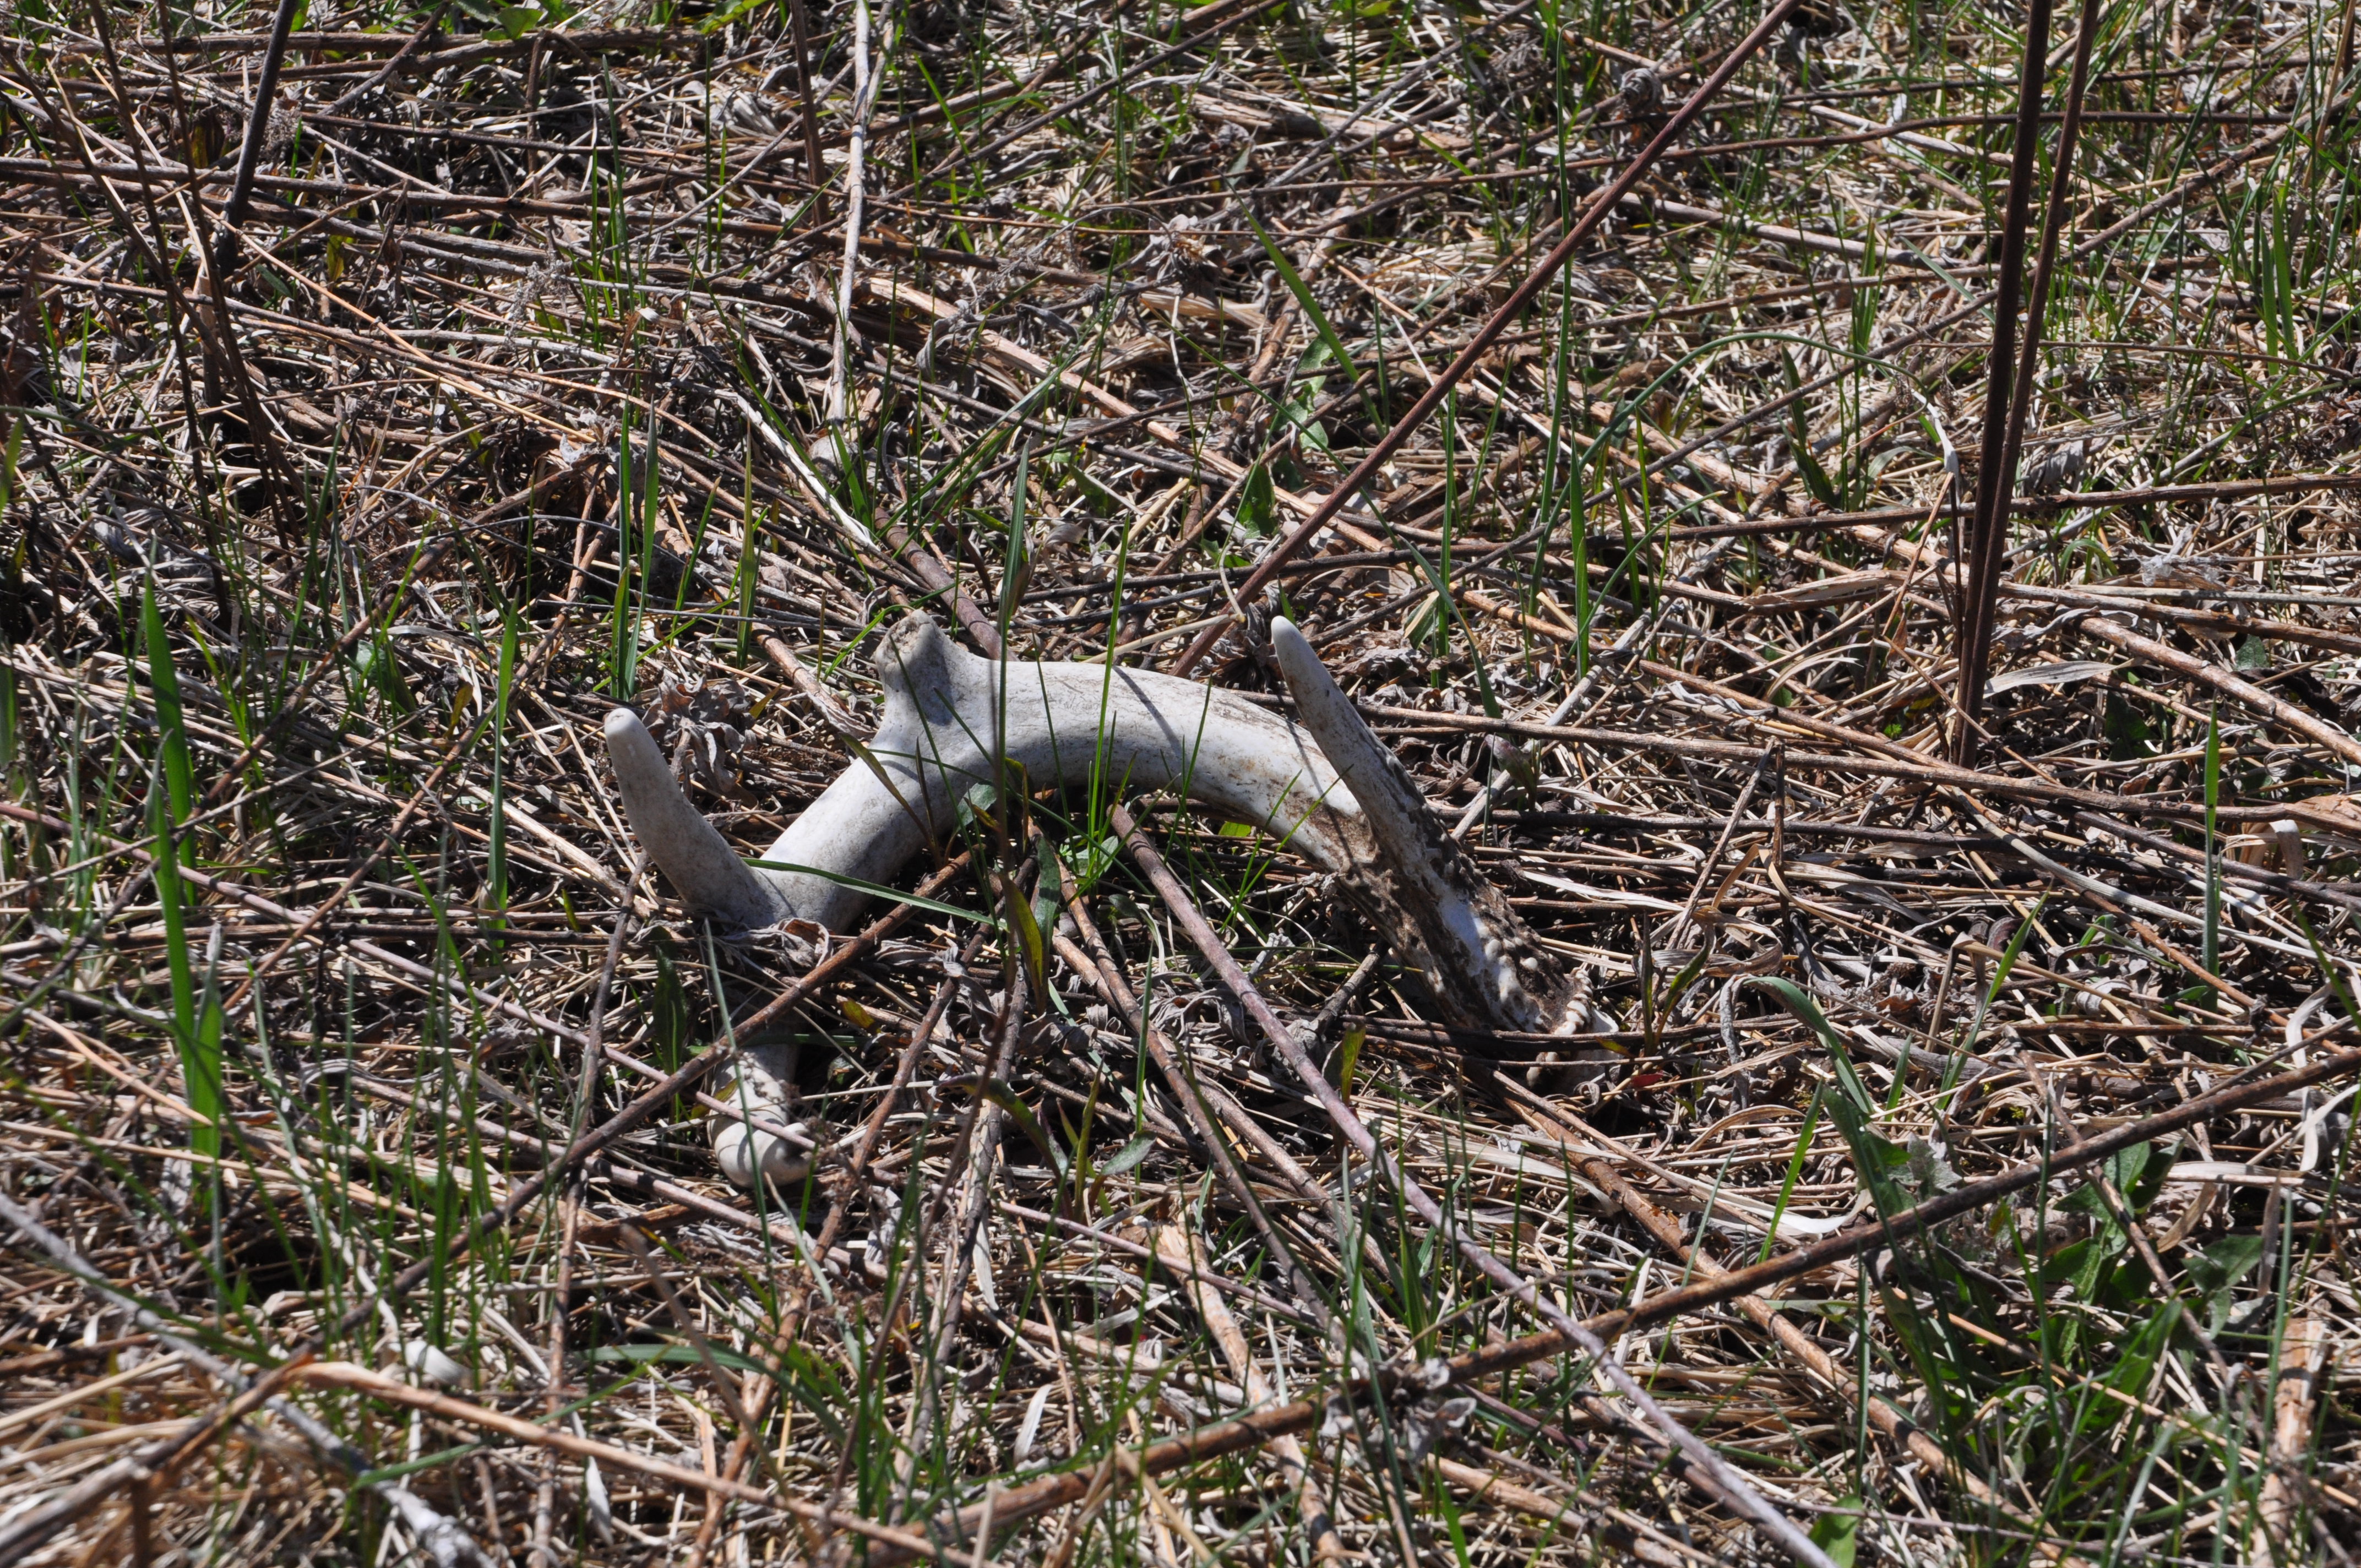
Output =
[{"x1": 607, "y1": 616, "x2": 1587, "y2": 1185}]
